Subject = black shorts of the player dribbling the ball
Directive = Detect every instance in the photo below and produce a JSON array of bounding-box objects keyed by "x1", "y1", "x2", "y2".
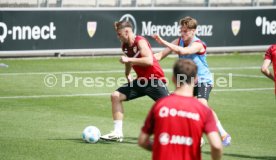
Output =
[{"x1": 117, "y1": 79, "x2": 169, "y2": 101}]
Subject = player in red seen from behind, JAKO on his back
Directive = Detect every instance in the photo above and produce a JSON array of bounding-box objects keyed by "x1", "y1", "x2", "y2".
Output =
[{"x1": 138, "y1": 59, "x2": 222, "y2": 160}]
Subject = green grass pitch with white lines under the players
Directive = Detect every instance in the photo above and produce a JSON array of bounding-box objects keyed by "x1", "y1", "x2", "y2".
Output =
[{"x1": 0, "y1": 54, "x2": 276, "y2": 160}]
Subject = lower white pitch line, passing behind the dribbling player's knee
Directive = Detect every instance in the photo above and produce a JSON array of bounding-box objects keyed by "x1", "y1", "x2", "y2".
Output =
[{"x1": 0, "y1": 88, "x2": 274, "y2": 99}]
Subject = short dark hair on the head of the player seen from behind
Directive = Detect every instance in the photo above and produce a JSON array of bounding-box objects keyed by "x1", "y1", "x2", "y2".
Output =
[{"x1": 173, "y1": 59, "x2": 197, "y2": 85}]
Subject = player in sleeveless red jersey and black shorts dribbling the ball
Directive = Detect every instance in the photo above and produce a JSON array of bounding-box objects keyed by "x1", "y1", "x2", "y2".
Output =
[{"x1": 101, "y1": 21, "x2": 169, "y2": 142}]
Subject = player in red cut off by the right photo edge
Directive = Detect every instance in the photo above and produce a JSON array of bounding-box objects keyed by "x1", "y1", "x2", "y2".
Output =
[{"x1": 261, "y1": 44, "x2": 276, "y2": 95}]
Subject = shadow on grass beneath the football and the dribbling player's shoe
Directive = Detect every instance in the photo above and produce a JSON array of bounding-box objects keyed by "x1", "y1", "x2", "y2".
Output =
[{"x1": 48, "y1": 137, "x2": 138, "y2": 145}]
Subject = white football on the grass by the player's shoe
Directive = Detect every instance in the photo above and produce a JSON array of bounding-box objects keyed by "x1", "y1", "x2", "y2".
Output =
[{"x1": 82, "y1": 126, "x2": 101, "y2": 143}]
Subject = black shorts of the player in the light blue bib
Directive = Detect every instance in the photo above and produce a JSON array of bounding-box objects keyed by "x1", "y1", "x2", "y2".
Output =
[{"x1": 194, "y1": 83, "x2": 212, "y2": 101}]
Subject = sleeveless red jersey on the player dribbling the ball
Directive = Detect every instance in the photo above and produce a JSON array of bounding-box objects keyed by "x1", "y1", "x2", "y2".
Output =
[{"x1": 122, "y1": 36, "x2": 166, "y2": 82}]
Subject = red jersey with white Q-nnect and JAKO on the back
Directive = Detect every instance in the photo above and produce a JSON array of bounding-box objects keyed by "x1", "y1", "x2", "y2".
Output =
[{"x1": 142, "y1": 94, "x2": 218, "y2": 160}]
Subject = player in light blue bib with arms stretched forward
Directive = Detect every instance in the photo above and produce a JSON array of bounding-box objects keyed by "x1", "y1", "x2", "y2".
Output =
[{"x1": 152, "y1": 17, "x2": 231, "y2": 146}]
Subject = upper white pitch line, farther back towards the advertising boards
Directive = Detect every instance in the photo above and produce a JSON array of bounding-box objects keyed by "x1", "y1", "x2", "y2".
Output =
[{"x1": 0, "y1": 66, "x2": 260, "y2": 76}]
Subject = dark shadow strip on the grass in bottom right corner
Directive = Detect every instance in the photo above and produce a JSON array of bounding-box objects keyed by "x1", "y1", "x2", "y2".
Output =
[{"x1": 202, "y1": 151, "x2": 276, "y2": 160}]
